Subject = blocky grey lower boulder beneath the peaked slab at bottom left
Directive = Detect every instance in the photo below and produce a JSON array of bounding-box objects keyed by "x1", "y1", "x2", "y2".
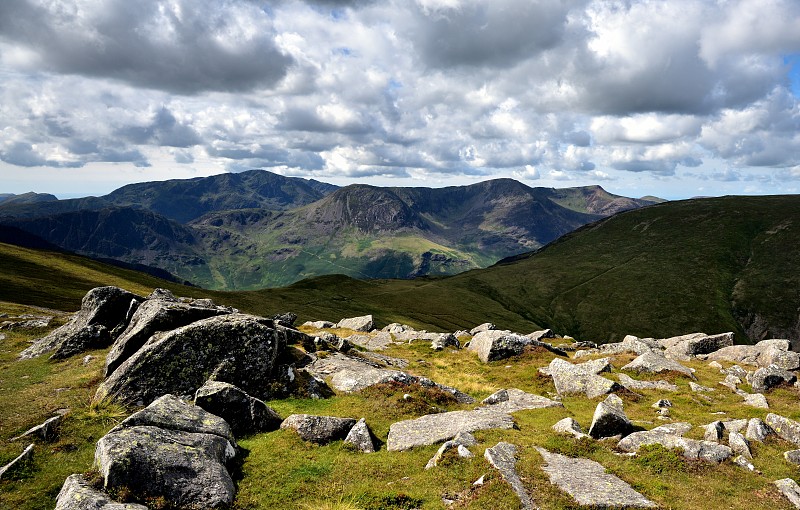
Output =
[{"x1": 95, "y1": 426, "x2": 235, "y2": 508}]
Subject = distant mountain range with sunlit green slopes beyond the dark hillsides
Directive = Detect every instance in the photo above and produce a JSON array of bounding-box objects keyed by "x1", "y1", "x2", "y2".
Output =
[{"x1": 0, "y1": 170, "x2": 657, "y2": 290}]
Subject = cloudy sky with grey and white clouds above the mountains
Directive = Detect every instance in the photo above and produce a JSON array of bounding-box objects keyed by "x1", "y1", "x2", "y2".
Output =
[{"x1": 0, "y1": 0, "x2": 800, "y2": 198}]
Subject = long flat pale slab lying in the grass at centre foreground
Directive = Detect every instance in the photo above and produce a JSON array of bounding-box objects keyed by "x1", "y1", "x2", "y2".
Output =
[{"x1": 386, "y1": 408, "x2": 514, "y2": 451}]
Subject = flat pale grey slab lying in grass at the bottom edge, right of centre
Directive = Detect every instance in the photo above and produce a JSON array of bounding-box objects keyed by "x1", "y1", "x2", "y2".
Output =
[{"x1": 536, "y1": 447, "x2": 658, "y2": 508}]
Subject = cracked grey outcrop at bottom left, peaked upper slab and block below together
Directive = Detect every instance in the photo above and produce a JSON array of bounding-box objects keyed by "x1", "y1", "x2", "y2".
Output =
[{"x1": 95, "y1": 395, "x2": 236, "y2": 508}]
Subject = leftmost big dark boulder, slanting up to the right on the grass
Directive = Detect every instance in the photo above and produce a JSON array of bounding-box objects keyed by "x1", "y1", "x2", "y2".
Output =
[{"x1": 19, "y1": 287, "x2": 144, "y2": 359}]
